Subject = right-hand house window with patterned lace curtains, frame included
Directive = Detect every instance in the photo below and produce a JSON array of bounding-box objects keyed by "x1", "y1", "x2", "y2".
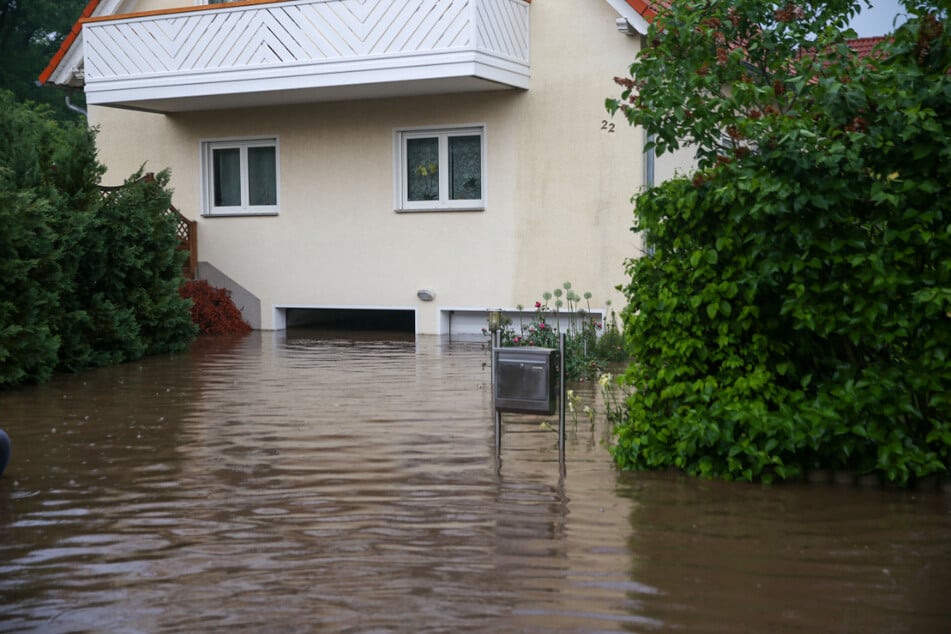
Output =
[{"x1": 395, "y1": 126, "x2": 485, "y2": 211}]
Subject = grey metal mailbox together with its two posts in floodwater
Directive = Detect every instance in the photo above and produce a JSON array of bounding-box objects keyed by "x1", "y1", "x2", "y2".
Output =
[{"x1": 492, "y1": 333, "x2": 565, "y2": 472}]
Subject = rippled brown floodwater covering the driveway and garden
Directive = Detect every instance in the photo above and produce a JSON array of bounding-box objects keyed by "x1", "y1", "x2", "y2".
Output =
[{"x1": 0, "y1": 332, "x2": 951, "y2": 633}]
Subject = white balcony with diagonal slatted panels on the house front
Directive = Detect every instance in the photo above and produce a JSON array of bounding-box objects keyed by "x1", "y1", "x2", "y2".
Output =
[{"x1": 82, "y1": 0, "x2": 529, "y2": 113}]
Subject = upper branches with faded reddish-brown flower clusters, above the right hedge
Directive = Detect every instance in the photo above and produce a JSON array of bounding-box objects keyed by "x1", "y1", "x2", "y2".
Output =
[{"x1": 608, "y1": 0, "x2": 872, "y2": 168}]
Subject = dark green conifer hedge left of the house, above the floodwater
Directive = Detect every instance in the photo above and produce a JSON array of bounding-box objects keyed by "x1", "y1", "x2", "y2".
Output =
[{"x1": 0, "y1": 92, "x2": 194, "y2": 387}]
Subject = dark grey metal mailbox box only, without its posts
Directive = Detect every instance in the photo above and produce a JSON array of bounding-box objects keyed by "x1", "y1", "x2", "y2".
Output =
[{"x1": 495, "y1": 346, "x2": 558, "y2": 415}]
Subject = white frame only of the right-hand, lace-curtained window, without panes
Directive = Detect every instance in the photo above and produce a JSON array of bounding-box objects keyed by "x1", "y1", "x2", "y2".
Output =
[{"x1": 393, "y1": 123, "x2": 488, "y2": 213}]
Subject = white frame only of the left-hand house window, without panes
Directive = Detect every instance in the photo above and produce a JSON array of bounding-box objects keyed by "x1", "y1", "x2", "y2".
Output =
[{"x1": 201, "y1": 135, "x2": 281, "y2": 216}]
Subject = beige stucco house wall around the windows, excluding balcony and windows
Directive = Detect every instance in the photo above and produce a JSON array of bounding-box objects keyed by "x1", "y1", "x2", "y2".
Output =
[{"x1": 90, "y1": 0, "x2": 643, "y2": 333}]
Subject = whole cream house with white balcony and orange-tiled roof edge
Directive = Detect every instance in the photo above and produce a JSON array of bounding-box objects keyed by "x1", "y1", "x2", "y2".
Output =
[{"x1": 40, "y1": 0, "x2": 652, "y2": 334}]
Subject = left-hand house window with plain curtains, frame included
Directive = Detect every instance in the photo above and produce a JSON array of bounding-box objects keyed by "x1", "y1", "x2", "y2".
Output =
[{"x1": 202, "y1": 138, "x2": 278, "y2": 216}]
